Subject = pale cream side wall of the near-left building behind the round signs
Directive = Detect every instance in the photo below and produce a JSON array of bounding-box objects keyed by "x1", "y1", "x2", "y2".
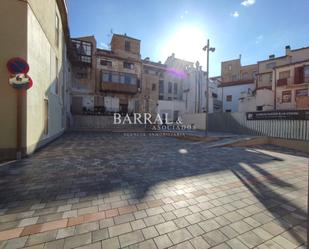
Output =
[{"x1": 26, "y1": 6, "x2": 66, "y2": 153}]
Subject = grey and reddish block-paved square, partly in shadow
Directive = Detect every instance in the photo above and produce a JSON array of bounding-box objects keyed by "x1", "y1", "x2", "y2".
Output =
[{"x1": 0, "y1": 133, "x2": 308, "y2": 249}]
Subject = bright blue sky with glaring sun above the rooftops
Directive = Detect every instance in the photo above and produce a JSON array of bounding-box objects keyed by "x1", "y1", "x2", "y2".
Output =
[{"x1": 67, "y1": 0, "x2": 309, "y2": 76}]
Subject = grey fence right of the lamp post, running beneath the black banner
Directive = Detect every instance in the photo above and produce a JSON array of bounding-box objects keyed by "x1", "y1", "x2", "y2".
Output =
[{"x1": 208, "y1": 112, "x2": 309, "y2": 141}]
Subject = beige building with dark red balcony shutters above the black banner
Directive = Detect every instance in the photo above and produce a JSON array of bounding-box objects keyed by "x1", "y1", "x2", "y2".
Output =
[{"x1": 256, "y1": 46, "x2": 309, "y2": 111}]
